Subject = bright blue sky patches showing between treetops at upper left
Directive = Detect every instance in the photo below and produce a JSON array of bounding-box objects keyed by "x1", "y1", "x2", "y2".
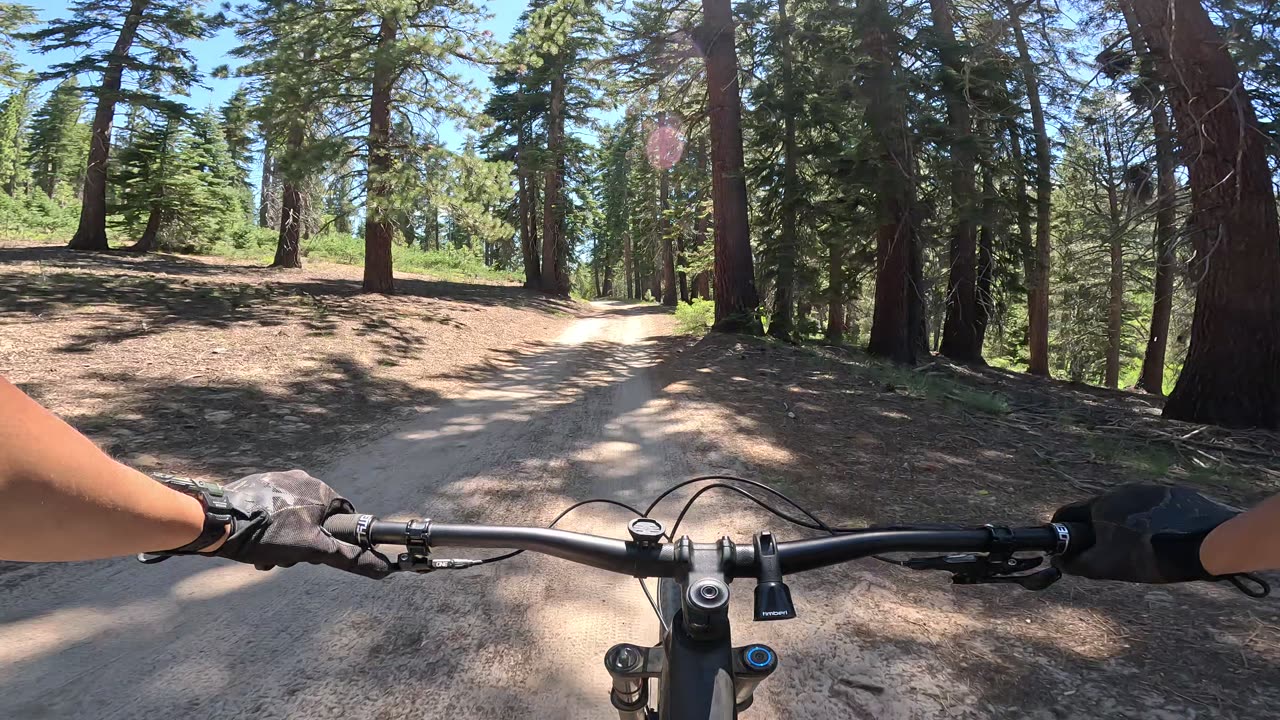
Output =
[{"x1": 15, "y1": 0, "x2": 522, "y2": 150}]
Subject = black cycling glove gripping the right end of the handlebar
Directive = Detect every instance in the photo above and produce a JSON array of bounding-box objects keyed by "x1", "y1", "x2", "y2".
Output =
[{"x1": 1053, "y1": 484, "x2": 1239, "y2": 583}]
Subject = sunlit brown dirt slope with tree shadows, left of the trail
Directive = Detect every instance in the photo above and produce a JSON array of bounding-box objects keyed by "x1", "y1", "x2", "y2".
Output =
[{"x1": 0, "y1": 243, "x2": 581, "y2": 477}]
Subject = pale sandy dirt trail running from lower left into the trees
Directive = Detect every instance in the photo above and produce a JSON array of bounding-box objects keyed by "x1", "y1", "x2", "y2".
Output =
[{"x1": 0, "y1": 304, "x2": 721, "y2": 720}]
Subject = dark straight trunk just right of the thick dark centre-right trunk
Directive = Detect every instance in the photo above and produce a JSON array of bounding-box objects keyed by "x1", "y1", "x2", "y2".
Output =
[{"x1": 929, "y1": 0, "x2": 982, "y2": 363}]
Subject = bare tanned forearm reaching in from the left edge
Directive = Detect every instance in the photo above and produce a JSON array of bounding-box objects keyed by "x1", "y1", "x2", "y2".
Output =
[{"x1": 0, "y1": 378, "x2": 218, "y2": 561}]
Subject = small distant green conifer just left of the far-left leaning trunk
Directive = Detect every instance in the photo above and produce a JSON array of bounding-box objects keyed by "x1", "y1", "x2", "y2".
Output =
[{"x1": 28, "y1": 77, "x2": 88, "y2": 199}]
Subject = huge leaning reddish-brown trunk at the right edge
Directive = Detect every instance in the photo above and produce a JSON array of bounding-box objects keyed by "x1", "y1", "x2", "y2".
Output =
[{"x1": 1124, "y1": 0, "x2": 1280, "y2": 428}]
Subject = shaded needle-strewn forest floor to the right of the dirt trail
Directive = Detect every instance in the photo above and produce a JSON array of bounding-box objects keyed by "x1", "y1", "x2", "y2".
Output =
[{"x1": 650, "y1": 336, "x2": 1280, "y2": 720}]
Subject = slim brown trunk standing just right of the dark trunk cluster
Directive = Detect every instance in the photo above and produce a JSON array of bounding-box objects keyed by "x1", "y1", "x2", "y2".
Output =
[{"x1": 1009, "y1": 3, "x2": 1053, "y2": 377}]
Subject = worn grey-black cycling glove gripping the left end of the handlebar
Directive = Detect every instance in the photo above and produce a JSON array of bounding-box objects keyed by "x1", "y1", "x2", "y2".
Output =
[{"x1": 197, "y1": 470, "x2": 392, "y2": 578}]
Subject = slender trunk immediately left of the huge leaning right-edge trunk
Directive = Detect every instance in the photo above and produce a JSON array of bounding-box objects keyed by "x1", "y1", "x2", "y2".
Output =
[{"x1": 1120, "y1": 3, "x2": 1178, "y2": 395}]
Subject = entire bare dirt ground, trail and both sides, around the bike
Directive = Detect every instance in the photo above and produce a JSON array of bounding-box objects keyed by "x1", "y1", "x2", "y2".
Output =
[{"x1": 0, "y1": 238, "x2": 1280, "y2": 720}]
